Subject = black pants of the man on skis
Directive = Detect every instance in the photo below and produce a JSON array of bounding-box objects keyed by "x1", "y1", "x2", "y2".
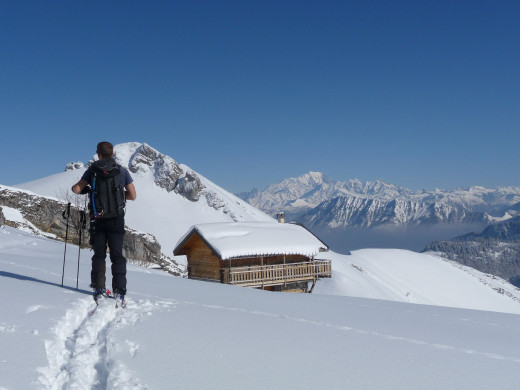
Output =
[{"x1": 90, "y1": 214, "x2": 126, "y2": 294}]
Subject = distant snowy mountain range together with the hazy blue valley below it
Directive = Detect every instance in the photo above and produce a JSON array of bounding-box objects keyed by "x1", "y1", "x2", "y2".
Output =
[{"x1": 240, "y1": 172, "x2": 520, "y2": 251}]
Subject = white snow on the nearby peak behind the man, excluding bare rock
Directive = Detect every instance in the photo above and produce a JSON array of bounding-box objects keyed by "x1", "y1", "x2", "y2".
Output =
[{"x1": 16, "y1": 142, "x2": 277, "y2": 257}]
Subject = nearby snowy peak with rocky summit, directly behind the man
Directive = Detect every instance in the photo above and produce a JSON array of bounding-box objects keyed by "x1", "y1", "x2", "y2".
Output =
[{"x1": 16, "y1": 142, "x2": 276, "y2": 257}]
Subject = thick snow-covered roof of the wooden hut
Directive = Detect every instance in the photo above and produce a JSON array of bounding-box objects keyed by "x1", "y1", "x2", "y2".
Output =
[{"x1": 174, "y1": 222, "x2": 329, "y2": 260}]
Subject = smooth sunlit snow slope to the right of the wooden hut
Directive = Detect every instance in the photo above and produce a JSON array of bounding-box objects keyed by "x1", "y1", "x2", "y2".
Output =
[{"x1": 314, "y1": 249, "x2": 520, "y2": 314}]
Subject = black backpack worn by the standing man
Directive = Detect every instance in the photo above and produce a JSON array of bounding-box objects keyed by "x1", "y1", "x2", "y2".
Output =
[{"x1": 89, "y1": 158, "x2": 125, "y2": 219}]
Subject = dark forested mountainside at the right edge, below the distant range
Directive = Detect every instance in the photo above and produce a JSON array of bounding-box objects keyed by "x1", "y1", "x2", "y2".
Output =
[{"x1": 424, "y1": 216, "x2": 520, "y2": 286}]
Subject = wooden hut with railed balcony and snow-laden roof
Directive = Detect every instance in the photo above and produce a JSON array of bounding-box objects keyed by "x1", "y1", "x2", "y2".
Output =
[{"x1": 174, "y1": 222, "x2": 331, "y2": 292}]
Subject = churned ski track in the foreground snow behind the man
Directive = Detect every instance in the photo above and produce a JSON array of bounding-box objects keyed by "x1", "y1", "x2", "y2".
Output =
[{"x1": 37, "y1": 297, "x2": 172, "y2": 390}]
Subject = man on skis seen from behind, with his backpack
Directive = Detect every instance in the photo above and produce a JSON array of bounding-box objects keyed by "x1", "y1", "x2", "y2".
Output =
[{"x1": 72, "y1": 142, "x2": 137, "y2": 306}]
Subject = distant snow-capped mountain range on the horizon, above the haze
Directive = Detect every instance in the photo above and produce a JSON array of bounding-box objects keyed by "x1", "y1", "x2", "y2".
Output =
[{"x1": 237, "y1": 172, "x2": 520, "y2": 229}]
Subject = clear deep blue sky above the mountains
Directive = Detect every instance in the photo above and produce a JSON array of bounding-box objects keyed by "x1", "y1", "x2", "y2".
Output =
[{"x1": 0, "y1": 0, "x2": 520, "y2": 192}]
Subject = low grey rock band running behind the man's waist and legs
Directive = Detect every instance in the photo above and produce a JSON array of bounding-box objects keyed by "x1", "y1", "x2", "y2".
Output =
[{"x1": 0, "y1": 186, "x2": 166, "y2": 272}]
